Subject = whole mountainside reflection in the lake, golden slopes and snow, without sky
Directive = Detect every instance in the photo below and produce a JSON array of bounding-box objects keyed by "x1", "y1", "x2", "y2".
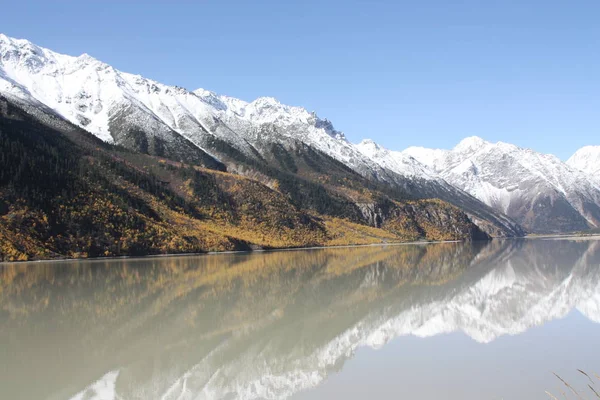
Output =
[{"x1": 0, "y1": 240, "x2": 600, "y2": 399}]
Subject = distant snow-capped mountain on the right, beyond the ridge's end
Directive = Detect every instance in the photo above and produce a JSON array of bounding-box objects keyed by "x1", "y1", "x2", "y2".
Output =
[{"x1": 403, "y1": 137, "x2": 600, "y2": 232}]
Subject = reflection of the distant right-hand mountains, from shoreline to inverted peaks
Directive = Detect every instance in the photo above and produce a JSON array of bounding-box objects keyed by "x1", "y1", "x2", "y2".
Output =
[{"x1": 356, "y1": 240, "x2": 600, "y2": 346}]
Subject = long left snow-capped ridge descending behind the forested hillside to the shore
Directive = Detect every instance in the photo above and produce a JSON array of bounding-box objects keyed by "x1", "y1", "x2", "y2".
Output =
[{"x1": 0, "y1": 35, "x2": 521, "y2": 236}]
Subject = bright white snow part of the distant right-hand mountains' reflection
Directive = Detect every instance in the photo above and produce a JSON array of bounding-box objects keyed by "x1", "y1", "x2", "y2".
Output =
[{"x1": 370, "y1": 246, "x2": 600, "y2": 345}]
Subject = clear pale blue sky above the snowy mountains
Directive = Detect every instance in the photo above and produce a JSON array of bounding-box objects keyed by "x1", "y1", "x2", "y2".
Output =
[{"x1": 0, "y1": 0, "x2": 600, "y2": 159}]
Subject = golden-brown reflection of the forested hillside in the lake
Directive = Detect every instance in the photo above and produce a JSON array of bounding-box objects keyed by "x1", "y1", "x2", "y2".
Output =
[{"x1": 0, "y1": 243, "x2": 496, "y2": 400}]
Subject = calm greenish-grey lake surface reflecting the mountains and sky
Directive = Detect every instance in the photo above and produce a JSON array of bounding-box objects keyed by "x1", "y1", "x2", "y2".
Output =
[{"x1": 0, "y1": 239, "x2": 600, "y2": 400}]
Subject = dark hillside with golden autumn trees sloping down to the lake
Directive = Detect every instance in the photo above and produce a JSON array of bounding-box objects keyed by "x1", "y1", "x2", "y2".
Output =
[{"x1": 0, "y1": 98, "x2": 487, "y2": 261}]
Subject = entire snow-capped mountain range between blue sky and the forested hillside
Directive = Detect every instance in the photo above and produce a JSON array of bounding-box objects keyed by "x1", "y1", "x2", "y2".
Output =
[{"x1": 0, "y1": 34, "x2": 600, "y2": 258}]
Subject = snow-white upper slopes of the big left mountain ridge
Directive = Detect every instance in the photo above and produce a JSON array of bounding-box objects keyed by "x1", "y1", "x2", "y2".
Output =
[{"x1": 0, "y1": 35, "x2": 385, "y2": 176}]
